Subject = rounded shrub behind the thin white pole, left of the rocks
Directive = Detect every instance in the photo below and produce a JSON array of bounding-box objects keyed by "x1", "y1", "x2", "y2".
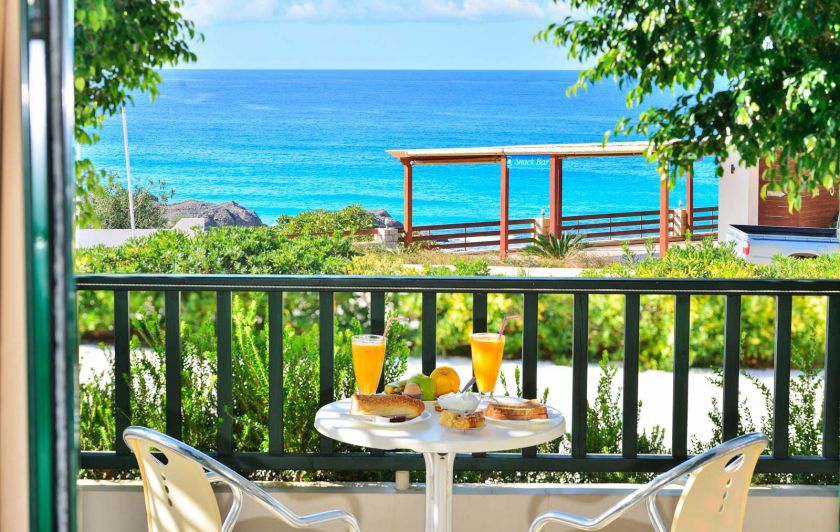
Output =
[{"x1": 91, "y1": 179, "x2": 174, "y2": 229}]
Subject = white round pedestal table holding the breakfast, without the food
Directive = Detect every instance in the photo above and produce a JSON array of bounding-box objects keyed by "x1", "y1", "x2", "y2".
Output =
[{"x1": 315, "y1": 399, "x2": 566, "y2": 532}]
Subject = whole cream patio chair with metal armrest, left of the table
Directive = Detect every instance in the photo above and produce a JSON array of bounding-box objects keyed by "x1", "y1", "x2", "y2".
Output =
[{"x1": 123, "y1": 427, "x2": 360, "y2": 532}]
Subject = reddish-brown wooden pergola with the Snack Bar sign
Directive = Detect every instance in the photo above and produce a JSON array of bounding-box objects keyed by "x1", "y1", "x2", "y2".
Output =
[{"x1": 388, "y1": 141, "x2": 694, "y2": 256}]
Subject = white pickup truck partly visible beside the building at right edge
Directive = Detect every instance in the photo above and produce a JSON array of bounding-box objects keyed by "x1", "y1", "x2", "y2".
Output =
[{"x1": 726, "y1": 225, "x2": 840, "y2": 264}]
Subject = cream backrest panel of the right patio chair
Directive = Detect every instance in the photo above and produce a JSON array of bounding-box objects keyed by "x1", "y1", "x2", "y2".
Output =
[{"x1": 671, "y1": 437, "x2": 767, "y2": 532}]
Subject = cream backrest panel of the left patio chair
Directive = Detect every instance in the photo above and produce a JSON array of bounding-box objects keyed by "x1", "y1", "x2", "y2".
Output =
[{"x1": 123, "y1": 427, "x2": 222, "y2": 532}]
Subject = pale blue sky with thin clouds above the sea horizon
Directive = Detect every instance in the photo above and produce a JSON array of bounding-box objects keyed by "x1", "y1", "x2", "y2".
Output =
[{"x1": 180, "y1": 0, "x2": 578, "y2": 70}]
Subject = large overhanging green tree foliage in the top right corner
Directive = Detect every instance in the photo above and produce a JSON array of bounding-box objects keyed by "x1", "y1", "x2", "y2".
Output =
[{"x1": 537, "y1": 0, "x2": 840, "y2": 208}]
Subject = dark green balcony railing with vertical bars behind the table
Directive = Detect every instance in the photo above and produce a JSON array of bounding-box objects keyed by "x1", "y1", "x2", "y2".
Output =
[{"x1": 76, "y1": 275, "x2": 840, "y2": 474}]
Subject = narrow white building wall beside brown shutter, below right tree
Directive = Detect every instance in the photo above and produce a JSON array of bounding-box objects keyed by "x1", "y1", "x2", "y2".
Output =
[{"x1": 718, "y1": 153, "x2": 759, "y2": 241}]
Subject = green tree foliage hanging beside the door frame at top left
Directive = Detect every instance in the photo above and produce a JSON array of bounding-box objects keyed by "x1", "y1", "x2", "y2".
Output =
[{"x1": 74, "y1": 0, "x2": 202, "y2": 225}]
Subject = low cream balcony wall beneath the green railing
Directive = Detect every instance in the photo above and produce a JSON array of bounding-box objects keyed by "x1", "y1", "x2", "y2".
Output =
[{"x1": 79, "y1": 481, "x2": 837, "y2": 532}]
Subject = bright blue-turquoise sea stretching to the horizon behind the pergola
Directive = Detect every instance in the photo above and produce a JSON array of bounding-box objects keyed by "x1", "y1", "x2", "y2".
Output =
[{"x1": 82, "y1": 70, "x2": 717, "y2": 224}]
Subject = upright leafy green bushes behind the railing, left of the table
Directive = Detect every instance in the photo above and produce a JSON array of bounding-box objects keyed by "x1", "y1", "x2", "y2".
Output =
[{"x1": 79, "y1": 295, "x2": 409, "y2": 479}]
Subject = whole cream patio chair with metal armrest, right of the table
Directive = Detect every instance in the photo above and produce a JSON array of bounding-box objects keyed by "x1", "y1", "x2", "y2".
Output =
[{"x1": 530, "y1": 433, "x2": 767, "y2": 532}]
